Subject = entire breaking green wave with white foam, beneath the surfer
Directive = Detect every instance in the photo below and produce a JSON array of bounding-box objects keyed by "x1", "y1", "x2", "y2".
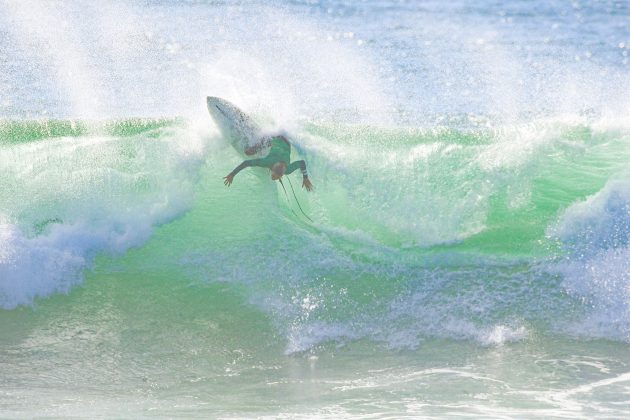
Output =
[{"x1": 0, "y1": 116, "x2": 630, "y2": 346}]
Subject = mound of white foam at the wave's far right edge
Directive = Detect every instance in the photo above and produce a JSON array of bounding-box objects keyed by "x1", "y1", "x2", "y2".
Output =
[{"x1": 548, "y1": 176, "x2": 630, "y2": 341}]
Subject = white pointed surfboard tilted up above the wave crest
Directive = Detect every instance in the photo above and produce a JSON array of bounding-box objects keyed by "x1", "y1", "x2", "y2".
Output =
[{"x1": 206, "y1": 96, "x2": 262, "y2": 158}]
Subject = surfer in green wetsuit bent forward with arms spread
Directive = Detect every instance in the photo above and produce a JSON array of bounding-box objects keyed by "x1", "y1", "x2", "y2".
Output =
[{"x1": 223, "y1": 135, "x2": 313, "y2": 191}]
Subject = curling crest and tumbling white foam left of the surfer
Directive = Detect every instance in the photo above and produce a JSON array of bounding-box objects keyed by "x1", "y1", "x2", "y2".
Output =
[{"x1": 0, "y1": 122, "x2": 209, "y2": 309}]
